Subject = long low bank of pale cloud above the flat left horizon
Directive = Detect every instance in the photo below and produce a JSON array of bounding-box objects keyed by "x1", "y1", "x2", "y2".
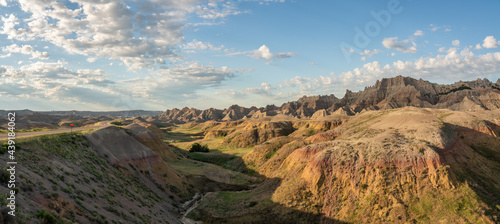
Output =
[{"x1": 0, "y1": 61, "x2": 251, "y2": 110}]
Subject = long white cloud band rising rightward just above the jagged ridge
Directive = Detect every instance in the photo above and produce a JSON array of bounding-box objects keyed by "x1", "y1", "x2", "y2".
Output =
[{"x1": 222, "y1": 48, "x2": 500, "y2": 100}]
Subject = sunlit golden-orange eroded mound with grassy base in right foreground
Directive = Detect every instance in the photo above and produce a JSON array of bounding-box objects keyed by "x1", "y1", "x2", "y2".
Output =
[{"x1": 183, "y1": 107, "x2": 500, "y2": 223}]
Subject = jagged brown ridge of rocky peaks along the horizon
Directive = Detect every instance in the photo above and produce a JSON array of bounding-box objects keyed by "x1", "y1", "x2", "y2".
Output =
[{"x1": 156, "y1": 76, "x2": 500, "y2": 123}]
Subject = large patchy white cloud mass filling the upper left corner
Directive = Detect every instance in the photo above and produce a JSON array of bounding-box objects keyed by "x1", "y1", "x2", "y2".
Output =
[{"x1": 0, "y1": 0, "x2": 258, "y2": 70}]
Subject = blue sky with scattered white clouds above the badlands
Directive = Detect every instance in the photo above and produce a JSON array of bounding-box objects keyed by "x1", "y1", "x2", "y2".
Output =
[{"x1": 0, "y1": 0, "x2": 500, "y2": 111}]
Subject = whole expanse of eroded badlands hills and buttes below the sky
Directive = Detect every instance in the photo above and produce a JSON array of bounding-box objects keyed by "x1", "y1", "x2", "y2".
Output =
[{"x1": 0, "y1": 76, "x2": 500, "y2": 223}]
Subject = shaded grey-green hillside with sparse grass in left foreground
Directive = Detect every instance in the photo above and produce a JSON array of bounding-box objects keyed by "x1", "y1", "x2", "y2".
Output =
[{"x1": 0, "y1": 133, "x2": 186, "y2": 223}]
